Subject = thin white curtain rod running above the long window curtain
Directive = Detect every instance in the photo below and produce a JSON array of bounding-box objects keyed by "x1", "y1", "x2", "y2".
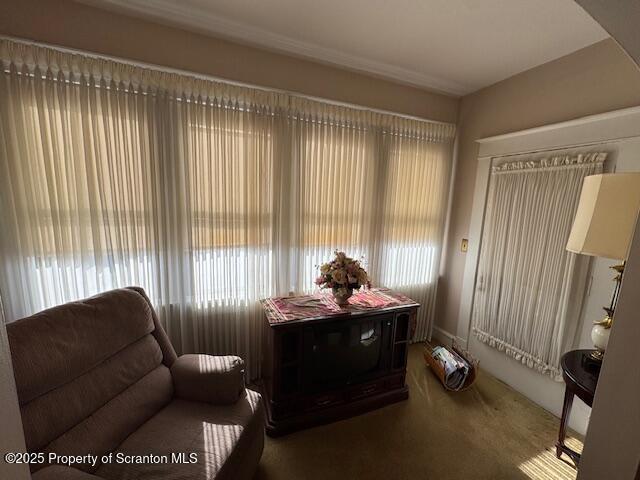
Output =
[{"x1": 0, "y1": 34, "x2": 457, "y2": 127}]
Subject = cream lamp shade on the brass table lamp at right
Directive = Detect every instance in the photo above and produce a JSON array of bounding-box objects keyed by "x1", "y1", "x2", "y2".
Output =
[{"x1": 567, "y1": 173, "x2": 640, "y2": 260}]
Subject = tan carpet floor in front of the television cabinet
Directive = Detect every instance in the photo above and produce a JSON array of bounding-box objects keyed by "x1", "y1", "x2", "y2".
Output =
[{"x1": 255, "y1": 345, "x2": 582, "y2": 480}]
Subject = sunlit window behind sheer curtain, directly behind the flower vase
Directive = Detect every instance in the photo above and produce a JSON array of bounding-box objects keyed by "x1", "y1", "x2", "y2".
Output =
[{"x1": 293, "y1": 119, "x2": 383, "y2": 292}]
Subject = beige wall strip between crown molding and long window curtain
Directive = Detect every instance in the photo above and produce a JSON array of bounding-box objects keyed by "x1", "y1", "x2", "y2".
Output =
[{"x1": 0, "y1": 0, "x2": 459, "y2": 122}]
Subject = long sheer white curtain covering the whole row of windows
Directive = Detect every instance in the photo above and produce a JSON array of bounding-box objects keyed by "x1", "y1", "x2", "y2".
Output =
[{"x1": 0, "y1": 40, "x2": 454, "y2": 375}]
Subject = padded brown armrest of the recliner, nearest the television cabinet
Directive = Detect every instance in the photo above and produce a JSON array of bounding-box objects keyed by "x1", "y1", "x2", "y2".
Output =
[{"x1": 171, "y1": 355, "x2": 245, "y2": 405}]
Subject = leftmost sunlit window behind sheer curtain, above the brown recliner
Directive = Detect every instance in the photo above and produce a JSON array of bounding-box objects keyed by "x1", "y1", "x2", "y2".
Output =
[{"x1": 0, "y1": 70, "x2": 158, "y2": 317}]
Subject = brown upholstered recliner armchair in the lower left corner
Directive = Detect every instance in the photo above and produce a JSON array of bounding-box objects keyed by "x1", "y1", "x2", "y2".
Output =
[{"x1": 7, "y1": 288, "x2": 264, "y2": 480}]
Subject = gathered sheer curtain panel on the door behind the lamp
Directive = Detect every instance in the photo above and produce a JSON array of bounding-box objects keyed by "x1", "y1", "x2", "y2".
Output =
[{"x1": 473, "y1": 153, "x2": 606, "y2": 378}]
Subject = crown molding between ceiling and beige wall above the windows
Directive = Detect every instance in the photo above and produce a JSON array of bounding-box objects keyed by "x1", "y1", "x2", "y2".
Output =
[{"x1": 78, "y1": 0, "x2": 474, "y2": 97}]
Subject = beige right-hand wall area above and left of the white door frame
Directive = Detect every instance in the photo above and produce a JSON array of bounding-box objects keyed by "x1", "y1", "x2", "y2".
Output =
[{"x1": 436, "y1": 40, "x2": 640, "y2": 335}]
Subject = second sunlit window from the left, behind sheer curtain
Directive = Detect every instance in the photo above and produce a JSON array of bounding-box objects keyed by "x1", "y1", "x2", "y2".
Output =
[{"x1": 184, "y1": 104, "x2": 276, "y2": 304}]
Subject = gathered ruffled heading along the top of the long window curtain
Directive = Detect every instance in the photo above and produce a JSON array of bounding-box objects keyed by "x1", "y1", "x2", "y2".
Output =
[{"x1": 0, "y1": 39, "x2": 455, "y2": 142}]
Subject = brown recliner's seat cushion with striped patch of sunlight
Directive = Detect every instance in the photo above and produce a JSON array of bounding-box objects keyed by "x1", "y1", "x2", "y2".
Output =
[{"x1": 96, "y1": 389, "x2": 264, "y2": 480}]
